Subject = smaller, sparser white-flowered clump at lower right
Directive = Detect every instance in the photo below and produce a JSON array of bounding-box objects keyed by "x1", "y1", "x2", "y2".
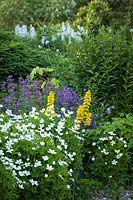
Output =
[{"x1": 87, "y1": 127, "x2": 130, "y2": 184}]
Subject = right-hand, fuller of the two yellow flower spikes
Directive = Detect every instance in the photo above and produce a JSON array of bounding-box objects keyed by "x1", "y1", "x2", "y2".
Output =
[{"x1": 76, "y1": 90, "x2": 92, "y2": 126}]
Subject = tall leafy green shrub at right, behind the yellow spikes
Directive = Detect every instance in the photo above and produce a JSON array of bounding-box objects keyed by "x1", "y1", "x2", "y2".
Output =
[{"x1": 69, "y1": 27, "x2": 133, "y2": 113}]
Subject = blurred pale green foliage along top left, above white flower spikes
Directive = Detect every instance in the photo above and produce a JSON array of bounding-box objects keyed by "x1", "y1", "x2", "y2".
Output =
[{"x1": 0, "y1": 0, "x2": 76, "y2": 26}]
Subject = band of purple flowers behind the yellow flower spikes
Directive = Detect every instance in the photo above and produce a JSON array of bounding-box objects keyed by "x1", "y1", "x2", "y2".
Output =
[{"x1": 0, "y1": 75, "x2": 80, "y2": 114}]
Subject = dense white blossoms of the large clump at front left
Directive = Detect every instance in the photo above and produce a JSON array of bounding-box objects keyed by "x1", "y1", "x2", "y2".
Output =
[{"x1": 0, "y1": 108, "x2": 82, "y2": 189}]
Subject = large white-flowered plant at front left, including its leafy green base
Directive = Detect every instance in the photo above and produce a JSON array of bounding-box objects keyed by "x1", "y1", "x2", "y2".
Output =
[{"x1": 0, "y1": 105, "x2": 83, "y2": 200}]
